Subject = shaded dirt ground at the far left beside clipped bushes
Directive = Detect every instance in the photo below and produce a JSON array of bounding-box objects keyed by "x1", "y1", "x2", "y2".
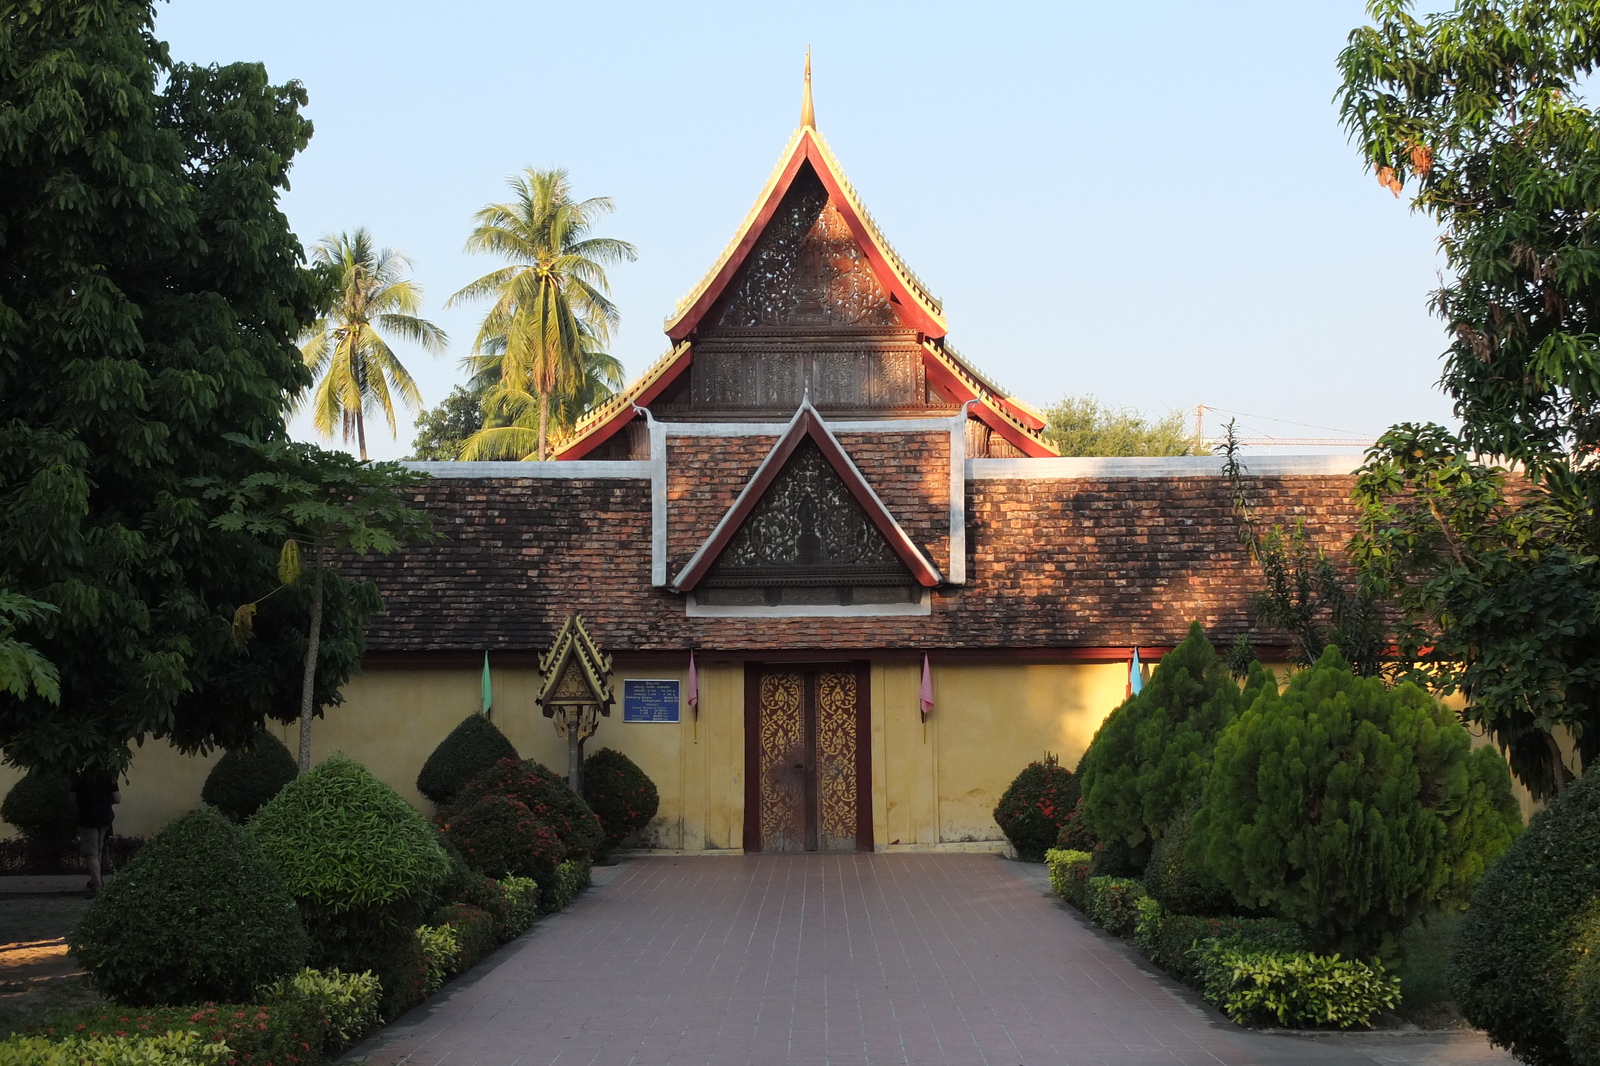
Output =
[{"x1": 0, "y1": 896, "x2": 104, "y2": 1039}]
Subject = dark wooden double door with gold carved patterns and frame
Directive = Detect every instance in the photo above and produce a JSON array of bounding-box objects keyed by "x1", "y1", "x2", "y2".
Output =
[{"x1": 744, "y1": 663, "x2": 872, "y2": 852}]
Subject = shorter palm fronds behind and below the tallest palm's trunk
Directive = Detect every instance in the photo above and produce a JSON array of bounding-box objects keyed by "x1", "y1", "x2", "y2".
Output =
[{"x1": 461, "y1": 321, "x2": 626, "y2": 459}]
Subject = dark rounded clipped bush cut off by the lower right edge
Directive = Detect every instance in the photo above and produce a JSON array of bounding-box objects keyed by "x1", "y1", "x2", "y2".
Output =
[{"x1": 1450, "y1": 758, "x2": 1600, "y2": 1066}]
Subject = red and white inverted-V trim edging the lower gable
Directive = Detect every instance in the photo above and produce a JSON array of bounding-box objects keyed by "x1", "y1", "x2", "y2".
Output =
[{"x1": 672, "y1": 400, "x2": 944, "y2": 592}]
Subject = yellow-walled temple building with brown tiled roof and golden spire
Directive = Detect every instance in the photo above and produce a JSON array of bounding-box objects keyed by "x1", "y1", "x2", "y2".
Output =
[{"x1": 6, "y1": 70, "x2": 1357, "y2": 852}]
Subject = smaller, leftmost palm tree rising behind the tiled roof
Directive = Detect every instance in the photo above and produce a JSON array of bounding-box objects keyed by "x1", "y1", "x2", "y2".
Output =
[{"x1": 301, "y1": 227, "x2": 446, "y2": 463}]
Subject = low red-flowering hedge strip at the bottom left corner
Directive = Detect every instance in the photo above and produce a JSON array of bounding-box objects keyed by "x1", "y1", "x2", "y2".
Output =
[{"x1": 40, "y1": 1000, "x2": 326, "y2": 1066}]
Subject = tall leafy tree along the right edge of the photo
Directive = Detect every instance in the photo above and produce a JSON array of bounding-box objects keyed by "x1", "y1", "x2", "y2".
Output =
[{"x1": 1339, "y1": 0, "x2": 1600, "y2": 795}]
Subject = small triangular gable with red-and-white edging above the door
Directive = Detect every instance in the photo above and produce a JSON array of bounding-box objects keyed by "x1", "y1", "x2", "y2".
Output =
[{"x1": 672, "y1": 403, "x2": 942, "y2": 592}]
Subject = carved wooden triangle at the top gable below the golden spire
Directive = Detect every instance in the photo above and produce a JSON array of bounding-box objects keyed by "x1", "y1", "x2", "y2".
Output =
[{"x1": 717, "y1": 163, "x2": 896, "y2": 330}]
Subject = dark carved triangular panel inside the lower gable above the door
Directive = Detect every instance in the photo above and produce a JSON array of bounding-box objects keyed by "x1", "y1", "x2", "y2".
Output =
[{"x1": 702, "y1": 440, "x2": 912, "y2": 587}]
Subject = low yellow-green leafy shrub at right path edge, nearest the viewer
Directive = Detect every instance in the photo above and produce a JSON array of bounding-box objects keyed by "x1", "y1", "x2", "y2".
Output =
[{"x1": 1195, "y1": 940, "x2": 1400, "y2": 1029}]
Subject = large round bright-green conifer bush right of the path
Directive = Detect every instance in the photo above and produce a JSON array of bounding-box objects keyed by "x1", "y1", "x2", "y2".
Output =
[{"x1": 1192, "y1": 648, "x2": 1522, "y2": 952}]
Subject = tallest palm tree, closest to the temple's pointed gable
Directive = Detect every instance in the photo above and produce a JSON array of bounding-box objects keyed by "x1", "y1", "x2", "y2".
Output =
[{"x1": 445, "y1": 166, "x2": 638, "y2": 461}]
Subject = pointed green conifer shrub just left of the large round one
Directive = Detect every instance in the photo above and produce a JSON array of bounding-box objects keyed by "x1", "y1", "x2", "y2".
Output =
[{"x1": 1082, "y1": 623, "x2": 1243, "y2": 871}]
